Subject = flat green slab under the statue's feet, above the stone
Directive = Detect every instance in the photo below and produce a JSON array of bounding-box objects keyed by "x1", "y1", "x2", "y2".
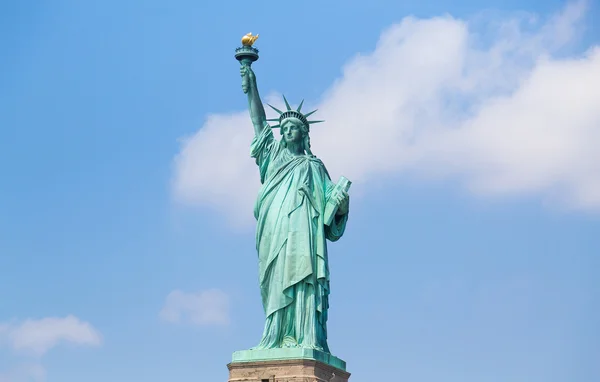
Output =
[{"x1": 231, "y1": 348, "x2": 346, "y2": 371}]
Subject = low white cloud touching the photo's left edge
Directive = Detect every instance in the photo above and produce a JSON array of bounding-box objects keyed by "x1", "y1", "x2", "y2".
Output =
[{"x1": 0, "y1": 316, "x2": 102, "y2": 356}]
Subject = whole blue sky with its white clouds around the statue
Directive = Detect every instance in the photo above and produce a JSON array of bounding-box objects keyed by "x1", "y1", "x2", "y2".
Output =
[{"x1": 0, "y1": 0, "x2": 600, "y2": 382}]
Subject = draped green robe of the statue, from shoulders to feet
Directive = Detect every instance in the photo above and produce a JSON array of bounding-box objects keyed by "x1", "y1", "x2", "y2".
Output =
[{"x1": 251, "y1": 125, "x2": 348, "y2": 352}]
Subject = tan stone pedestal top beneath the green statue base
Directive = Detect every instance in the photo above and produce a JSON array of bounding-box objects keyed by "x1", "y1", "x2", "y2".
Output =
[{"x1": 227, "y1": 359, "x2": 350, "y2": 382}]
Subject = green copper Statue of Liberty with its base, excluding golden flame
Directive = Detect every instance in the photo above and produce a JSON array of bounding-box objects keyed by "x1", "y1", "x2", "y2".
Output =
[{"x1": 234, "y1": 35, "x2": 350, "y2": 358}]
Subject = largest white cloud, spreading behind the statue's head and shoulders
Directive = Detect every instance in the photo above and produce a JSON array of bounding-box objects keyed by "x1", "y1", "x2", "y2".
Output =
[{"x1": 174, "y1": 2, "x2": 600, "y2": 223}]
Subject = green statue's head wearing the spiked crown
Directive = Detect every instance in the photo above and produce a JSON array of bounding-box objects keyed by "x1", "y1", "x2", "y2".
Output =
[{"x1": 269, "y1": 96, "x2": 323, "y2": 154}]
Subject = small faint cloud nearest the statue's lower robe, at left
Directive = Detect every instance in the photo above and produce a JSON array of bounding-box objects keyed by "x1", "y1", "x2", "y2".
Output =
[{"x1": 160, "y1": 289, "x2": 229, "y2": 325}]
